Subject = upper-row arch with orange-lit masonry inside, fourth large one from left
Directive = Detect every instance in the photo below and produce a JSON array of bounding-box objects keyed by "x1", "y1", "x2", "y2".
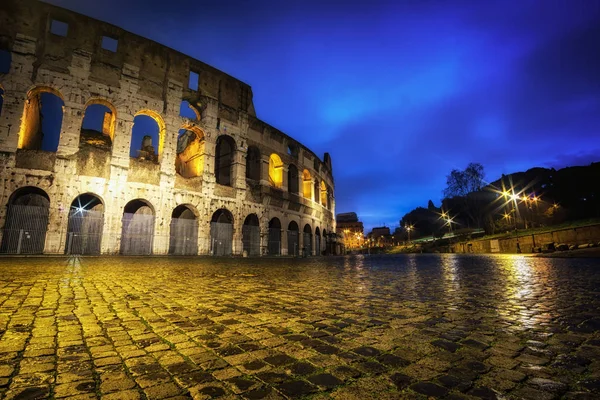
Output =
[{"x1": 175, "y1": 126, "x2": 205, "y2": 178}]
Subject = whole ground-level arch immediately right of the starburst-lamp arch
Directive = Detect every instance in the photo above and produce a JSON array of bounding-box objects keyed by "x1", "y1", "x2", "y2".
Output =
[{"x1": 121, "y1": 199, "x2": 154, "y2": 255}]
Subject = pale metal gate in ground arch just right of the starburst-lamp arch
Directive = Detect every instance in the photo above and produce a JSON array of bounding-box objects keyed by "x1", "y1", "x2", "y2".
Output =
[{"x1": 121, "y1": 213, "x2": 154, "y2": 255}]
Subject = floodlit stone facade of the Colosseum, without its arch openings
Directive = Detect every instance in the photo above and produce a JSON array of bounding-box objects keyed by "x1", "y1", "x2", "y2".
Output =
[{"x1": 0, "y1": 0, "x2": 335, "y2": 255}]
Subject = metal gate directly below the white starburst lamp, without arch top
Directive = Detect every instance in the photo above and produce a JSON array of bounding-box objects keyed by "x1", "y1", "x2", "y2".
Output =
[{"x1": 65, "y1": 209, "x2": 104, "y2": 254}]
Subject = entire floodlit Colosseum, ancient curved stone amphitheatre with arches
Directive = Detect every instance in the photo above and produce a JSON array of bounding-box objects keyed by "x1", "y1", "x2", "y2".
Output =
[{"x1": 0, "y1": 0, "x2": 335, "y2": 256}]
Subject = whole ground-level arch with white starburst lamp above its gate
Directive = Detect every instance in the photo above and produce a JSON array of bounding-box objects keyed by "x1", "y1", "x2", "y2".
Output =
[{"x1": 65, "y1": 193, "x2": 104, "y2": 254}]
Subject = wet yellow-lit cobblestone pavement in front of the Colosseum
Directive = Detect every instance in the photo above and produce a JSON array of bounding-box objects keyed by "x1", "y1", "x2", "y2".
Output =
[{"x1": 0, "y1": 255, "x2": 600, "y2": 400}]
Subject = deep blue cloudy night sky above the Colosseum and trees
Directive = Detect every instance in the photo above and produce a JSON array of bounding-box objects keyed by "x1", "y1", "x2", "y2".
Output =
[{"x1": 50, "y1": 0, "x2": 600, "y2": 229}]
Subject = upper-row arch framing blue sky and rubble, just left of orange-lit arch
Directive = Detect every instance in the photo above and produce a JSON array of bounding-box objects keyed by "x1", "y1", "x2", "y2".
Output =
[{"x1": 129, "y1": 110, "x2": 166, "y2": 163}]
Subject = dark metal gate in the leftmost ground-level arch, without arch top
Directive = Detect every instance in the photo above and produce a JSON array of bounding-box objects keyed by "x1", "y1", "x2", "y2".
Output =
[{"x1": 0, "y1": 204, "x2": 49, "y2": 254}]
